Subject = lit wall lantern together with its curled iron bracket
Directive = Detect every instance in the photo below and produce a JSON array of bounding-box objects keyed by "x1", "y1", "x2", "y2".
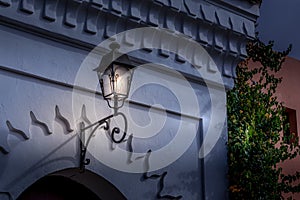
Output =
[{"x1": 79, "y1": 42, "x2": 134, "y2": 172}]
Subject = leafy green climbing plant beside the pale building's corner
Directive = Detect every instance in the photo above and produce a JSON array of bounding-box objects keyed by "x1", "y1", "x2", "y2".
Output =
[{"x1": 227, "y1": 40, "x2": 300, "y2": 200}]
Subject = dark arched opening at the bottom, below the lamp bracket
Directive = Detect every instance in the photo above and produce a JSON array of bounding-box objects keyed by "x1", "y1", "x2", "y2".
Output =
[{"x1": 17, "y1": 168, "x2": 126, "y2": 200}]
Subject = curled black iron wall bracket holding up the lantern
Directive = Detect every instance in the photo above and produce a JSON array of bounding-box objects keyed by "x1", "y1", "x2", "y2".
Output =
[{"x1": 79, "y1": 112, "x2": 127, "y2": 172}]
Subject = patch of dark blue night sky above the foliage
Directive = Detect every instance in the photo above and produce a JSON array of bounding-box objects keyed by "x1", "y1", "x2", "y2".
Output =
[{"x1": 257, "y1": 0, "x2": 300, "y2": 60}]
